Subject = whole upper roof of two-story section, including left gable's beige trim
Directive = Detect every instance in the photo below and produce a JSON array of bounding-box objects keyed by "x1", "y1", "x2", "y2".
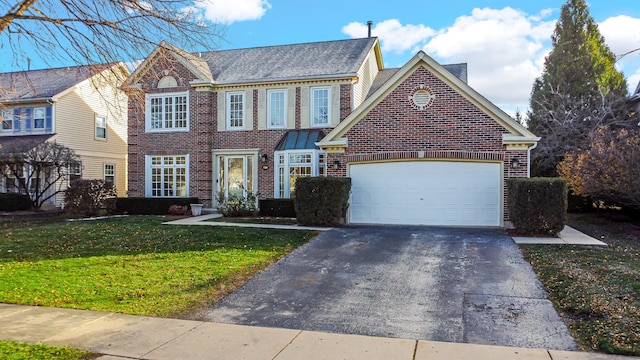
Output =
[{"x1": 127, "y1": 38, "x2": 381, "y2": 86}]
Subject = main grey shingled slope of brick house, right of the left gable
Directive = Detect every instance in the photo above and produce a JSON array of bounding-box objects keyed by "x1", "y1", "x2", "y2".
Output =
[{"x1": 197, "y1": 38, "x2": 377, "y2": 84}]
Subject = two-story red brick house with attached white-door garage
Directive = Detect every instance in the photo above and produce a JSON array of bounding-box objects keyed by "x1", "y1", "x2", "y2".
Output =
[{"x1": 127, "y1": 38, "x2": 538, "y2": 226}]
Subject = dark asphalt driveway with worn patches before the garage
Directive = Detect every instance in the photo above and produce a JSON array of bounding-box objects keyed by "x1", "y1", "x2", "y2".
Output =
[{"x1": 199, "y1": 226, "x2": 577, "y2": 350}]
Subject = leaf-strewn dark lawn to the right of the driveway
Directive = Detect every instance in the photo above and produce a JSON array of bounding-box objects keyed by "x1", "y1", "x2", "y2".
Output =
[{"x1": 521, "y1": 214, "x2": 640, "y2": 355}]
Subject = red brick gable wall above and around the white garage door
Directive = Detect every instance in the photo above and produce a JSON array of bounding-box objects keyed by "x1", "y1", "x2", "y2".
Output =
[{"x1": 328, "y1": 67, "x2": 528, "y2": 220}]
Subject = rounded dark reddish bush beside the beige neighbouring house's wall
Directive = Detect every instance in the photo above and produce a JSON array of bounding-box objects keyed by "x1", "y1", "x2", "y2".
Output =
[{"x1": 64, "y1": 179, "x2": 118, "y2": 216}]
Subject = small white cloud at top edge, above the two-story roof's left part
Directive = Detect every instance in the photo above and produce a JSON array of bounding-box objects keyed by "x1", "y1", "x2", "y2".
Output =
[{"x1": 194, "y1": 0, "x2": 271, "y2": 25}]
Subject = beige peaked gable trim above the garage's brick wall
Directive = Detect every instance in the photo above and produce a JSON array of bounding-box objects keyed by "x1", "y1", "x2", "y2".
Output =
[{"x1": 318, "y1": 51, "x2": 540, "y2": 148}]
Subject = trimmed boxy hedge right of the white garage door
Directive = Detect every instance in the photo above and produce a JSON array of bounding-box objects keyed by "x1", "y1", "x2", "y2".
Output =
[{"x1": 507, "y1": 178, "x2": 567, "y2": 235}]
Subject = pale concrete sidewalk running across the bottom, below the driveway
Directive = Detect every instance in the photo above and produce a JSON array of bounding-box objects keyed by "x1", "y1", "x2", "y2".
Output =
[{"x1": 0, "y1": 304, "x2": 638, "y2": 360}]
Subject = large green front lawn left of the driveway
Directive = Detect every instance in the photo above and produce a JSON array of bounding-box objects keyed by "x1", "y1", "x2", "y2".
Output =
[{"x1": 0, "y1": 216, "x2": 316, "y2": 316}]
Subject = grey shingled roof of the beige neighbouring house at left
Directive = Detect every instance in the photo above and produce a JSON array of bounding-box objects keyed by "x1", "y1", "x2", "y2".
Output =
[{"x1": 0, "y1": 65, "x2": 107, "y2": 103}]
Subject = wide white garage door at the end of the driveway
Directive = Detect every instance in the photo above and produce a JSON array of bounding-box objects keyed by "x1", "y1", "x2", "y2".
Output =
[{"x1": 349, "y1": 161, "x2": 501, "y2": 226}]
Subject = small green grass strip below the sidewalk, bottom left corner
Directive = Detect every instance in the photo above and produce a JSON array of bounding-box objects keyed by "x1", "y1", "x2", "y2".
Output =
[{"x1": 0, "y1": 341, "x2": 98, "y2": 360}]
